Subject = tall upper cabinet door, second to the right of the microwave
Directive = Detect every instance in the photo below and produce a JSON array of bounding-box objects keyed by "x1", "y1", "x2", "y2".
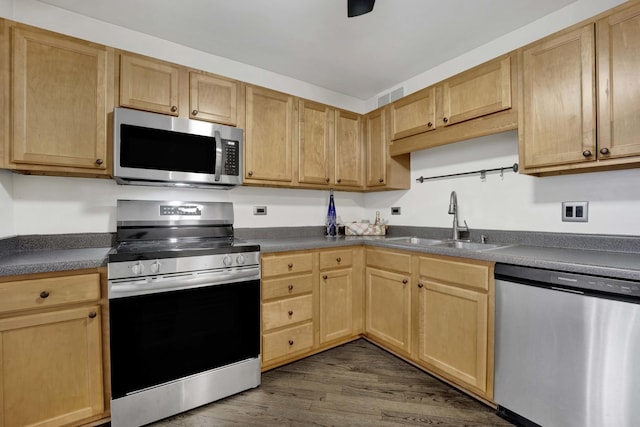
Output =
[{"x1": 298, "y1": 99, "x2": 333, "y2": 186}]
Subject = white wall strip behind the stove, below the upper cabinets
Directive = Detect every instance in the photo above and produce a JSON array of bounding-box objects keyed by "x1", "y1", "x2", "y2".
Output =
[{"x1": 10, "y1": 175, "x2": 364, "y2": 236}]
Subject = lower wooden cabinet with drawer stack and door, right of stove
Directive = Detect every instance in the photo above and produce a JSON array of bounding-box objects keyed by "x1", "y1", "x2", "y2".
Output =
[{"x1": 262, "y1": 247, "x2": 363, "y2": 370}]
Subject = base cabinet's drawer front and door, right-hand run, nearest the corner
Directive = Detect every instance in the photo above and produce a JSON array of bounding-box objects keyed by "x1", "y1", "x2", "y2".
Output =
[{"x1": 365, "y1": 248, "x2": 412, "y2": 357}]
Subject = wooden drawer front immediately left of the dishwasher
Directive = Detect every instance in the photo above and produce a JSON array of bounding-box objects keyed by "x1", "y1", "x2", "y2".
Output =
[{"x1": 420, "y1": 257, "x2": 490, "y2": 291}]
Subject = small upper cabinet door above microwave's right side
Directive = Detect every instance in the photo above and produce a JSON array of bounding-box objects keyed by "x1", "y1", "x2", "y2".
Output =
[{"x1": 189, "y1": 71, "x2": 239, "y2": 126}]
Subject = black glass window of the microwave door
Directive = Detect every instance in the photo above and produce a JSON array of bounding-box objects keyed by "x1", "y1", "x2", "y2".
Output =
[{"x1": 120, "y1": 124, "x2": 216, "y2": 174}]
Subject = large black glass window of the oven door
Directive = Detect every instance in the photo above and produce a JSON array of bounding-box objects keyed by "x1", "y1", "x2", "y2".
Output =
[{"x1": 109, "y1": 280, "x2": 260, "y2": 399}]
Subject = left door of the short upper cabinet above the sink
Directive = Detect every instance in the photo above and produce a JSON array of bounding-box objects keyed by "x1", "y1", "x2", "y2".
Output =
[{"x1": 391, "y1": 87, "x2": 436, "y2": 140}]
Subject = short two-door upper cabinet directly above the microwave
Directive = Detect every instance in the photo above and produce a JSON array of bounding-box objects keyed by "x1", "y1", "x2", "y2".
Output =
[{"x1": 118, "y1": 52, "x2": 240, "y2": 126}]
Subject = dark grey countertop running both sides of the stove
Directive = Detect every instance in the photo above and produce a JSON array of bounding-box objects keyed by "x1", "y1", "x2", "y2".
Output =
[{"x1": 0, "y1": 232, "x2": 640, "y2": 281}]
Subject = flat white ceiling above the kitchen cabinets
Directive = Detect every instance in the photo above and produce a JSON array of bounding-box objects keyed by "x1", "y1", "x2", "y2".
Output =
[{"x1": 40, "y1": 0, "x2": 576, "y2": 100}]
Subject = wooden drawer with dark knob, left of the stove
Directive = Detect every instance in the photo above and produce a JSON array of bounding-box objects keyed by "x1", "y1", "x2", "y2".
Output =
[{"x1": 0, "y1": 273, "x2": 100, "y2": 313}]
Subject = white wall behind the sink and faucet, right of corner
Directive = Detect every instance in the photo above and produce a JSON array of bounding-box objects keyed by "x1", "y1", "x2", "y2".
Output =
[{"x1": 365, "y1": 131, "x2": 640, "y2": 235}]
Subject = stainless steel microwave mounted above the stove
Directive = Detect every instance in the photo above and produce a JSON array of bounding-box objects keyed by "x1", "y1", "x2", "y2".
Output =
[{"x1": 113, "y1": 108, "x2": 243, "y2": 189}]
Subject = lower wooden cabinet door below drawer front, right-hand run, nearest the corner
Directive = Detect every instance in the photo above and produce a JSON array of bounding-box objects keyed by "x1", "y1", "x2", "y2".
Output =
[{"x1": 365, "y1": 267, "x2": 411, "y2": 354}]
